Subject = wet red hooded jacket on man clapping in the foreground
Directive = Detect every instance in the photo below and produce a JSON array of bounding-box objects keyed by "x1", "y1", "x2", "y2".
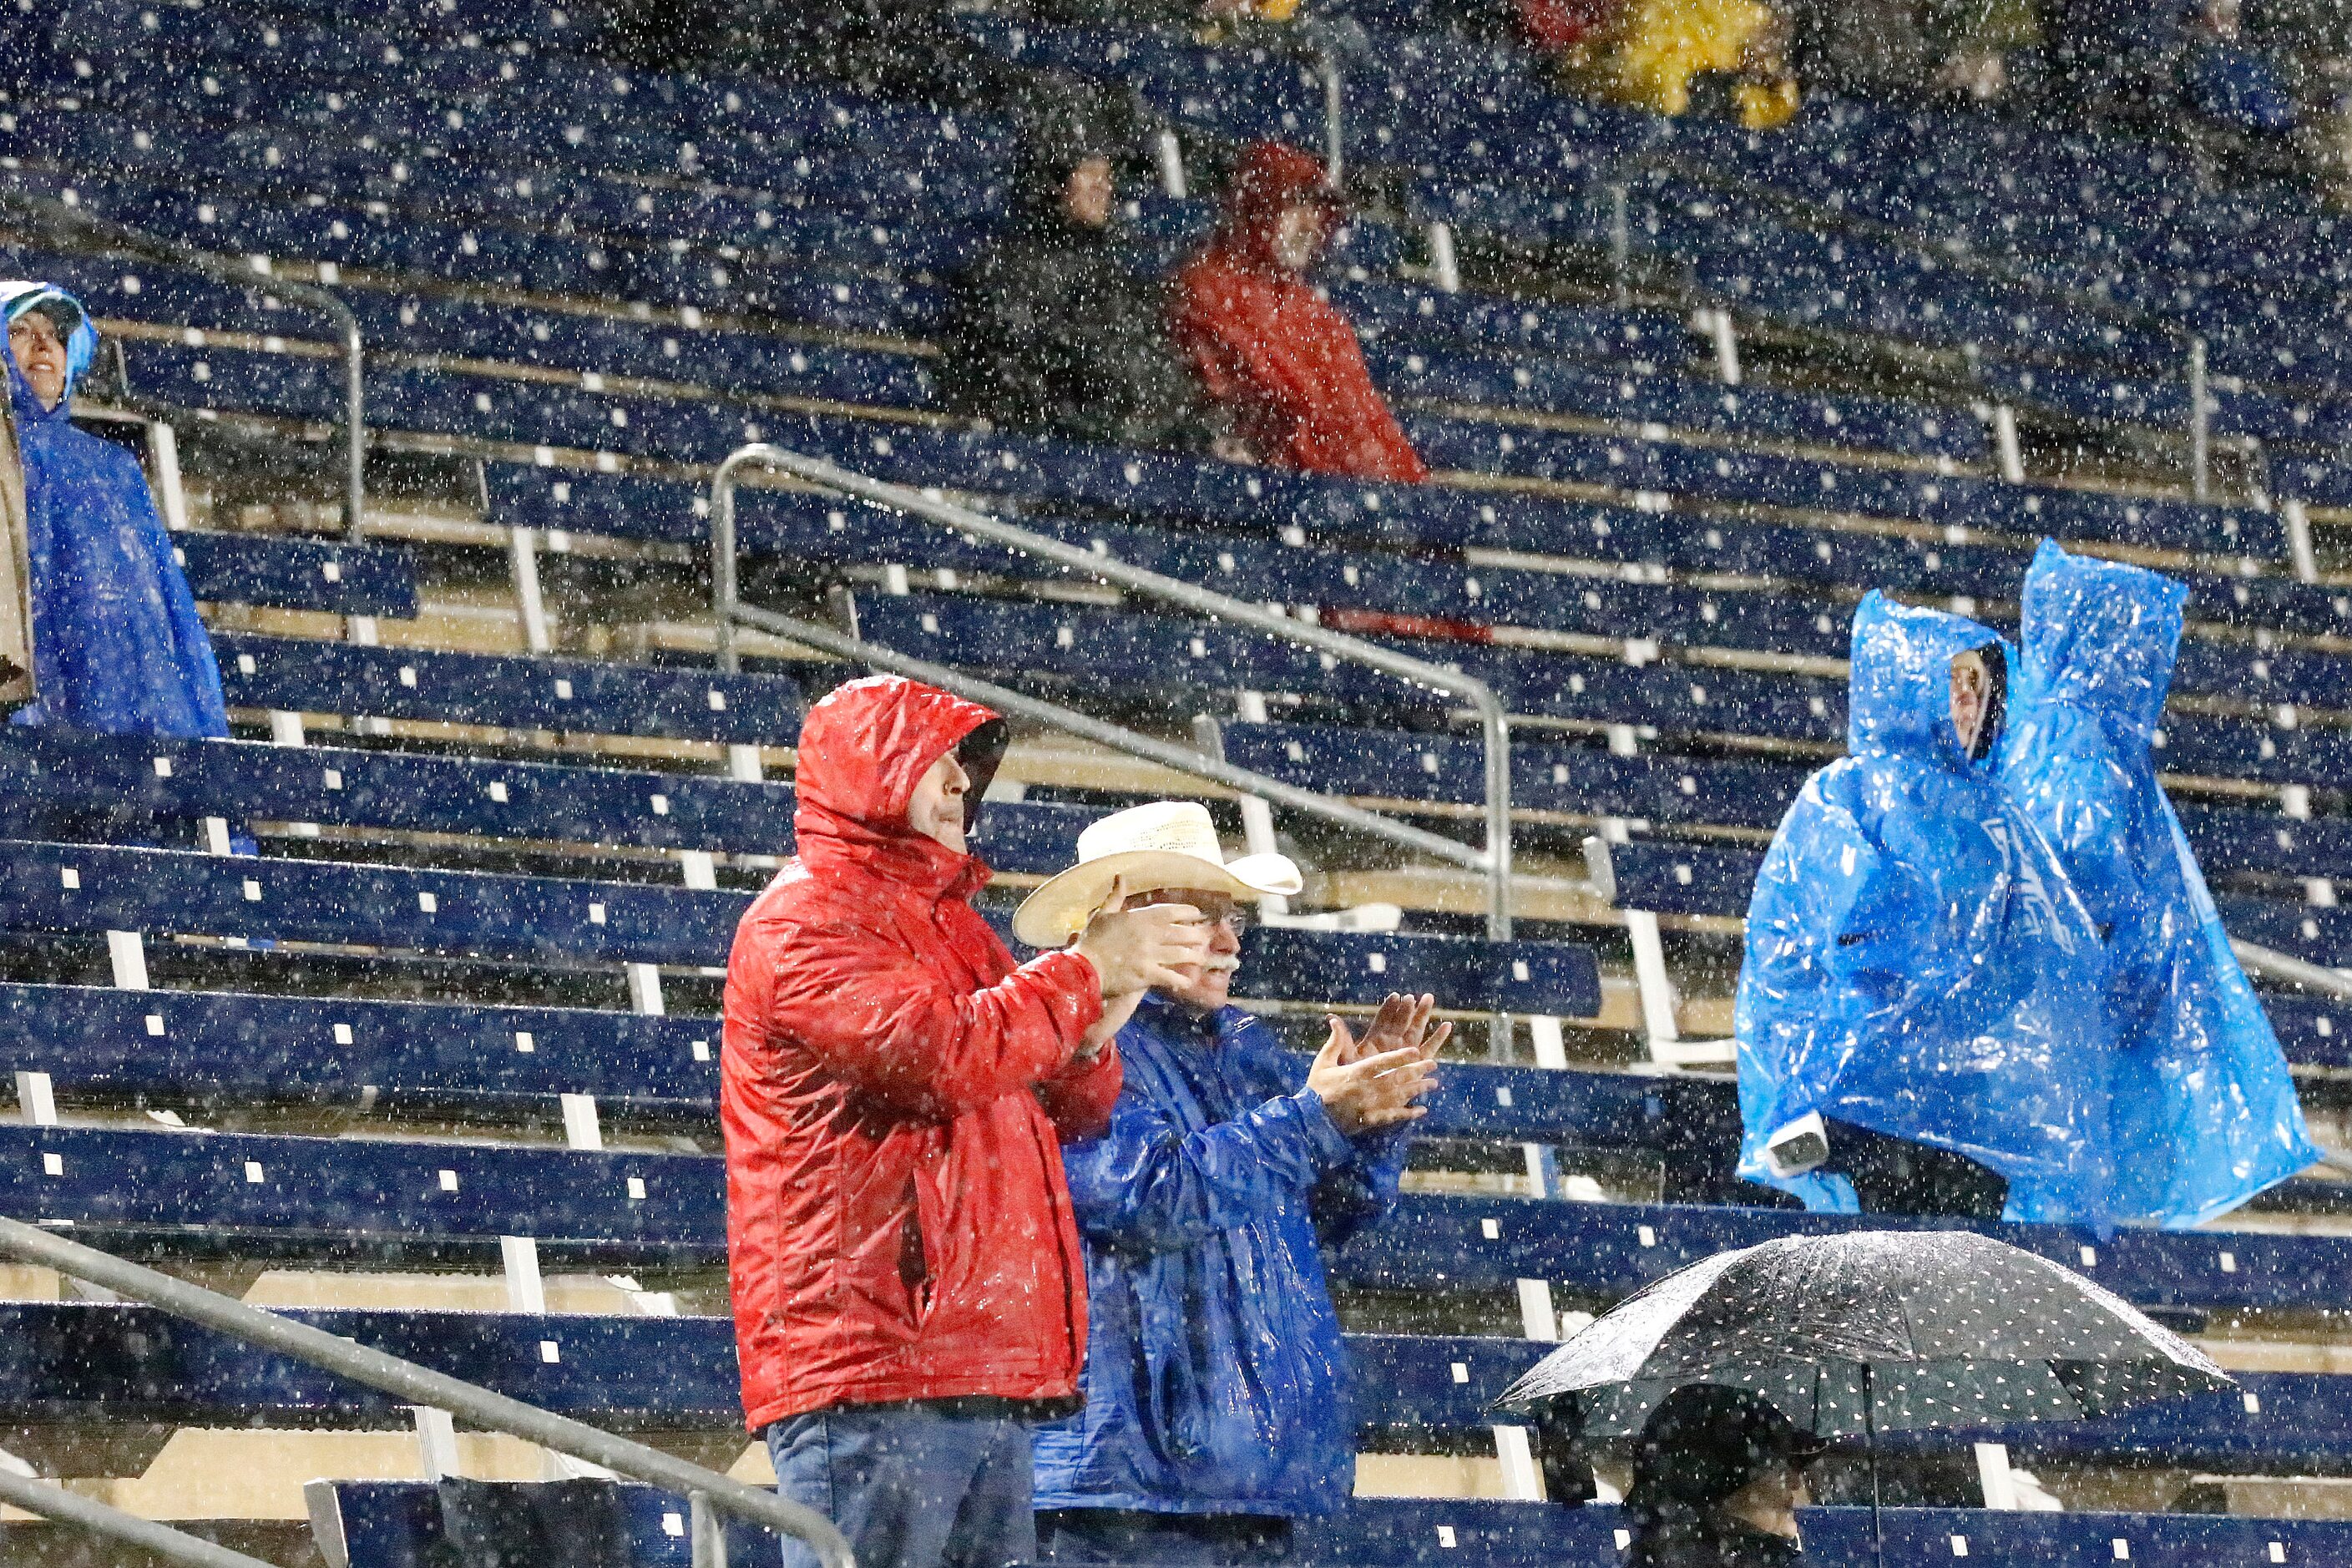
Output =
[{"x1": 720, "y1": 675, "x2": 1120, "y2": 1432}]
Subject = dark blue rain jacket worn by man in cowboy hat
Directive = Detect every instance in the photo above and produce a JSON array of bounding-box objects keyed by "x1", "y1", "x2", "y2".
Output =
[{"x1": 1034, "y1": 994, "x2": 1407, "y2": 1519}]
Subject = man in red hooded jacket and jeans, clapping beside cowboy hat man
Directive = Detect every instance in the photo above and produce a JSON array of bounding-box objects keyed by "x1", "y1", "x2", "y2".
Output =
[{"x1": 720, "y1": 675, "x2": 1209, "y2": 1568}]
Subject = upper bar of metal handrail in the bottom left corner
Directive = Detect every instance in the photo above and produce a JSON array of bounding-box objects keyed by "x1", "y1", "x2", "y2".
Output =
[{"x1": 0, "y1": 1217, "x2": 856, "y2": 1568}]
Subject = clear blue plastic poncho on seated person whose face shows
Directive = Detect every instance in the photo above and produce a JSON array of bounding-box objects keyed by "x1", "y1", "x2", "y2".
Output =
[{"x1": 1733, "y1": 593, "x2": 2112, "y2": 1227}]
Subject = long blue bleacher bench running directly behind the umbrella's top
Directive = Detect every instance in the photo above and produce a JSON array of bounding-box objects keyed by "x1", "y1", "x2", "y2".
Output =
[{"x1": 0, "y1": 1126, "x2": 2352, "y2": 1312}]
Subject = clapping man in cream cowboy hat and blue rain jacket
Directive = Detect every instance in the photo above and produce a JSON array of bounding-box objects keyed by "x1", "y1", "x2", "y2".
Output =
[{"x1": 1014, "y1": 802, "x2": 1451, "y2": 1563}]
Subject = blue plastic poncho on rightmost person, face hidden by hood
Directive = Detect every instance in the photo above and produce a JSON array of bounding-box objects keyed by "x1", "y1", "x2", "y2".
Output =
[{"x1": 2001, "y1": 541, "x2": 2319, "y2": 1227}]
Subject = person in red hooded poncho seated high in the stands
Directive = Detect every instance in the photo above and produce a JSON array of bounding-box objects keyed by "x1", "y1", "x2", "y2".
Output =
[{"x1": 1174, "y1": 141, "x2": 1430, "y2": 484}]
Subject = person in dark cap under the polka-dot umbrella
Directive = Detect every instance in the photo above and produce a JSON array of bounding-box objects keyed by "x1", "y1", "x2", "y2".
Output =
[{"x1": 1626, "y1": 1383, "x2": 1820, "y2": 1568}]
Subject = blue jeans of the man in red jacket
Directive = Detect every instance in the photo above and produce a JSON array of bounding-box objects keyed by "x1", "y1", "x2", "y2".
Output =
[{"x1": 766, "y1": 1399, "x2": 1037, "y2": 1568}]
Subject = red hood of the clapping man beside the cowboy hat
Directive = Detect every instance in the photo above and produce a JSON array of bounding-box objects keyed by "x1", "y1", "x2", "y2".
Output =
[{"x1": 792, "y1": 675, "x2": 997, "y2": 874}]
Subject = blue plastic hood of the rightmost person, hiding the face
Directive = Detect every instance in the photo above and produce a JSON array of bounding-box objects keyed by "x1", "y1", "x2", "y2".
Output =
[{"x1": 2018, "y1": 539, "x2": 2190, "y2": 733}]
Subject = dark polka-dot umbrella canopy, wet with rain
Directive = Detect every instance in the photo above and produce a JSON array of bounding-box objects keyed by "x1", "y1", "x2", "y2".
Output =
[{"x1": 1498, "y1": 1232, "x2": 2230, "y2": 1439}]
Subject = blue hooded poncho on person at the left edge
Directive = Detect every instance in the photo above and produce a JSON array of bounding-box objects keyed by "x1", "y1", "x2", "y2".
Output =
[{"x1": 0, "y1": 282, "x2": 228, "y2": 736}]
